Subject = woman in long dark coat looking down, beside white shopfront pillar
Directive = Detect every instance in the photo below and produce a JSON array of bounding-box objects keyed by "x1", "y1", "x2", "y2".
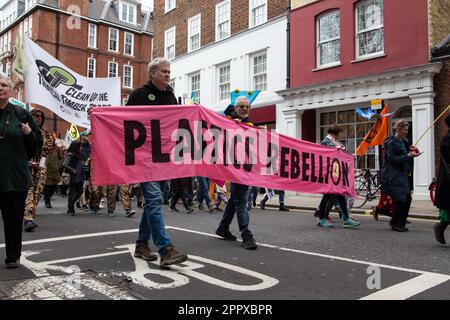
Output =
[{"x1": 381, "y1": 119, "x2": 420, "y2": 232}]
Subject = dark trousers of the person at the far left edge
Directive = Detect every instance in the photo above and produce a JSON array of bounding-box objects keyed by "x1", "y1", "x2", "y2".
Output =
[{"x1": 0, "y1": 190, "x2": 28, "y2": 263}]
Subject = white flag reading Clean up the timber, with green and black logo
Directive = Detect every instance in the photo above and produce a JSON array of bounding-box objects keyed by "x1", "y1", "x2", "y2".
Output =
[{"x1": 23, "y1": 37, "x2": 121, "y2": 128}]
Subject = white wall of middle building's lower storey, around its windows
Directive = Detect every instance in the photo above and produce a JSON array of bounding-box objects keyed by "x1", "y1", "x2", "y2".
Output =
[{"x1": 171, "y1": 16, "x2": 287, "y2": 121}]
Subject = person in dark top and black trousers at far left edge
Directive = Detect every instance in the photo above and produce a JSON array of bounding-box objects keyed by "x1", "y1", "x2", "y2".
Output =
[{"x1": 0, "y1": 73, "x2": 42, "y2": 269}]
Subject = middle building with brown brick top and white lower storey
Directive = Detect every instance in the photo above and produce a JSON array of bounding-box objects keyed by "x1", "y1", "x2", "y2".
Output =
[{"x1": 153, "y1": 0, "x2": 289, "y2": 128}]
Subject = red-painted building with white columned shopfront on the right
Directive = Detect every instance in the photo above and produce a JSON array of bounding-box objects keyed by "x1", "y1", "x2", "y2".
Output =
[{"x1": 279, "y1": 0, "x2": 450, "y2": 199}]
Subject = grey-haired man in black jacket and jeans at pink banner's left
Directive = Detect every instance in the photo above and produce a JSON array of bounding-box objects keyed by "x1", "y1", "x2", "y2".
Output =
[{"x1": 127, "y1": 58, "x2": 188, "y2": 268}]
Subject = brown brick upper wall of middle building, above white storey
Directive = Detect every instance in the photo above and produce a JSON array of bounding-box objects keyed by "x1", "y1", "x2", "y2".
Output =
[{"x1": 153, "y1": 0, "x2": 288, "y2": 57}]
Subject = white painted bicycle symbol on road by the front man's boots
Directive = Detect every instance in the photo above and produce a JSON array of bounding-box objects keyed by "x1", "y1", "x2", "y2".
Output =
[{"x1": 11, "y1": 244, "x2": 279, "y2": 299}]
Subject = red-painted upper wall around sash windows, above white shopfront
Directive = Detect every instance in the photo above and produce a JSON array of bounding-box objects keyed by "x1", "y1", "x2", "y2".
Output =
[{"x1": 290, "y1": 0, "x2": 429, "y2": 88}]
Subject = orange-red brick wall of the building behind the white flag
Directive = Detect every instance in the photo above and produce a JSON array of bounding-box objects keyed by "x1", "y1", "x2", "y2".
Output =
[{"x1": 1, "y1": 6, "x2": 152, "y2": 138}]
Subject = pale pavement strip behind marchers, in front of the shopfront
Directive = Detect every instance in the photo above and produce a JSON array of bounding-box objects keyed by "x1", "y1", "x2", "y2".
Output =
[{"x1": 257, "y1": 194, "x2": 438, "y2": 220}]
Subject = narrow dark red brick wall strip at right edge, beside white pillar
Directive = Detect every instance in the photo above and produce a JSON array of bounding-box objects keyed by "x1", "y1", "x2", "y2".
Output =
[{"x1": 434, "y1": 59, "x2": 450, "y2": 174}]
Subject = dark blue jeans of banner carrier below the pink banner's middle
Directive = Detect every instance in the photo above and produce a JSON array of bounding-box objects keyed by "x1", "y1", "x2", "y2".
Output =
[{"x1": 218, "y1": 183, "x2": 253, "y2": 241}]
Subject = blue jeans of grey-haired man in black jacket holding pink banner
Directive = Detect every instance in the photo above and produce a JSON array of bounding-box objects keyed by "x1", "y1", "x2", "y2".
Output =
[{"x1": 136, "y1": 181, "x2": 172, "y2": 253}]
